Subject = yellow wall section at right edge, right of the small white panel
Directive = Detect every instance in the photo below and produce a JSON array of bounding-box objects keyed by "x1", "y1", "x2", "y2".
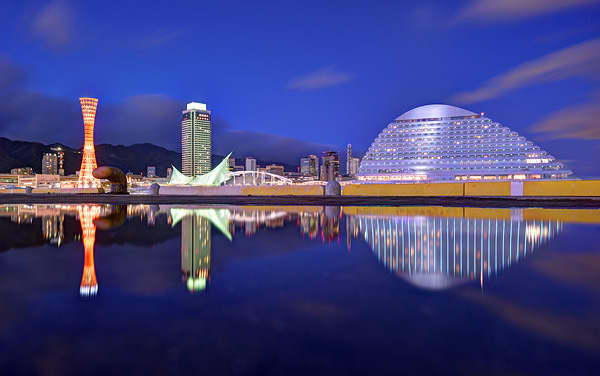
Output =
[{"x1": 523, "y1": 180, "x2": 600, "y2": 197}]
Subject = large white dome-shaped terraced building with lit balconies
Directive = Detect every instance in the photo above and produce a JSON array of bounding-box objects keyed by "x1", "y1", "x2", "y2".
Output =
[{"x1": 357, "y1": 104, "x2": 572, "y2": 182}]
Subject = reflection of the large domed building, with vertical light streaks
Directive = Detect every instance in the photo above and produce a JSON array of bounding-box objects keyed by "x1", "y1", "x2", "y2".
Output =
[{"x1": 346, "y1": 215, "x2": 563, "y2": 290}]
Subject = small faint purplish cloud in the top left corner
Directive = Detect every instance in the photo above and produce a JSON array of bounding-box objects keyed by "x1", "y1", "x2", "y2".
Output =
[{"x1": 31, "y1": 0, "x2": 75, "y2": 50}]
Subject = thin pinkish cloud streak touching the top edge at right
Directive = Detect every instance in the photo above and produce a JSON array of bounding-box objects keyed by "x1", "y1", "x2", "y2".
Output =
[{"x1": 457, "y1": 0, "x2": 599, "y2": 22}]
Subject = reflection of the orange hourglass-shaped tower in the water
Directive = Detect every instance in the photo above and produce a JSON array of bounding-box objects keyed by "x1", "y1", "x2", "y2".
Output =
[{"x1": 77, "y1": 205, "x2": 100, "y2": 296}]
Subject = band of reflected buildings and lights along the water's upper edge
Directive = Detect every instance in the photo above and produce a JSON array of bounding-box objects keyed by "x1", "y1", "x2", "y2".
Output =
[{"x1": 0, "y1": 205, "x2": 600, "y2": 297}]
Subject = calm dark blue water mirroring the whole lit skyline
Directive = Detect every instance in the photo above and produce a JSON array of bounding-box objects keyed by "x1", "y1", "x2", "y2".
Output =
[{"x1": 0, "y1": 205, "x2": 600, "y2": 375}]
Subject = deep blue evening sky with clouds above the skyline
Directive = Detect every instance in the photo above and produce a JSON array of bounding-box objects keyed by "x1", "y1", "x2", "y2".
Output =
[{"x1": 0, "y1": 0, "x2": 600, "y2": 176}]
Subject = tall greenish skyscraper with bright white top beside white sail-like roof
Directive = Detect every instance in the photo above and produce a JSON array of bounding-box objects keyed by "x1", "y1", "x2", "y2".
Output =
[{"x1": 181, "y1": 102, "x2": 212, "y2": 176}]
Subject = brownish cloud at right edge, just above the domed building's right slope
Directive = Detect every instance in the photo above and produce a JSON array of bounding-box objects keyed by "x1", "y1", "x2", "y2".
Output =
[{"x1": 531, "y1": 92, "x2": 600, "y2": 140}]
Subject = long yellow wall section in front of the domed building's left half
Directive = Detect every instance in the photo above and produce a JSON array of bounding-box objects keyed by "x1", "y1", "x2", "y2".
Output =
[{"x1": 342, "y1": 183, "x2": 463, "y2": 196}]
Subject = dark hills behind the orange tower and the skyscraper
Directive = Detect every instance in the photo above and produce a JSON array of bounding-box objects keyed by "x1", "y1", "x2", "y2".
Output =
[{"x1": 0, "y1": 137, "x2": 296, "y2": 176}]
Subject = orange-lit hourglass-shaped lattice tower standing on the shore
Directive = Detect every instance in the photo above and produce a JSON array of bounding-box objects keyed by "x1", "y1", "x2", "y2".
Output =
[{"x1": 77, "y1": 98, "x2": 99, "y2": 188}]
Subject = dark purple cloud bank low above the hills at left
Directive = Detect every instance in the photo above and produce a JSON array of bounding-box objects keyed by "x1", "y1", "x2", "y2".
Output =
[{"x1": 0, "y1": 57, "x2": 334, "y2": 165}]
